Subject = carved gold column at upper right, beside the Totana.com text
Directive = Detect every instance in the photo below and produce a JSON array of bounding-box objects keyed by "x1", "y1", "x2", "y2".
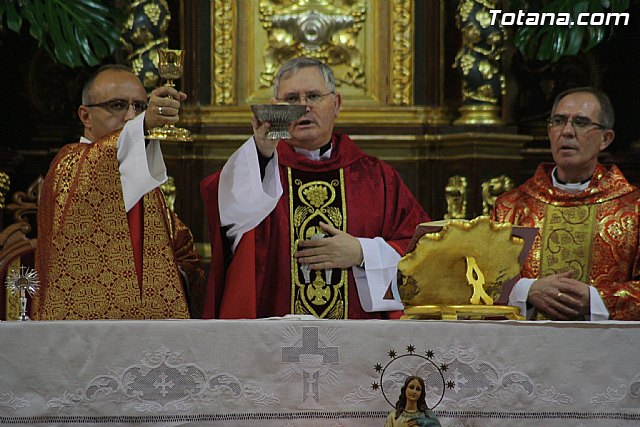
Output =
[{"x1": 454, "y1": 0, "x2": 506, "y2": 125}]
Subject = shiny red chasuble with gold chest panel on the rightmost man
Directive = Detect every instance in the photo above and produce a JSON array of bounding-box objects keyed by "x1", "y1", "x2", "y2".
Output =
[{"x1": 494, "y1": 163, "x2": 640, "y2": 320}]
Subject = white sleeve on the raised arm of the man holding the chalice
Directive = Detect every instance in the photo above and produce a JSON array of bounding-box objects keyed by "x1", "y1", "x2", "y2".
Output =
[{"x1": 118, "y1": 113, "x2": 167, "y2": 212}]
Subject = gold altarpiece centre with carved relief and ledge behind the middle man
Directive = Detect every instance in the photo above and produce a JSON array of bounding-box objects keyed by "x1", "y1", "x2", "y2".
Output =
[{"x1": 181, "y1": 0, "x2": 456, "y2": 131}]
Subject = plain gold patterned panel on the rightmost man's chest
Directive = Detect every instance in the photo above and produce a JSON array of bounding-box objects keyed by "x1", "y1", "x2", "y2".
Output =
[{"x1": 540, "y1": 205, "x2": 596, "y2": 283}]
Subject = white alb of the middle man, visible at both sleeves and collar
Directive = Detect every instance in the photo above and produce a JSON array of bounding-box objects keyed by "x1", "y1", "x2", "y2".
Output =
[{"x1": 218, "y1": 138, "x2": 403, "y2": 312}]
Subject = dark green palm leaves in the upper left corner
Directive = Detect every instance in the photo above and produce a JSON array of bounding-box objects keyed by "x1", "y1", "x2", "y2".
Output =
[{"x1": 0, "y1": 0, "x2": 125, "y2": 67}]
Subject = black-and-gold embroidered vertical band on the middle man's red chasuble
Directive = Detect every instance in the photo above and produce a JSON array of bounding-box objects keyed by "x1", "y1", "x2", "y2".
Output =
[{"x1": 287, "y1": 168, "x2": 349, "y2": 319}]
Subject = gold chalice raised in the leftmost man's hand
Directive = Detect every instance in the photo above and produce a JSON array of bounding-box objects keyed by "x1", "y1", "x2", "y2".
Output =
[{"x1": 146, "y1": 49, "x2": 192, "y2": 142}]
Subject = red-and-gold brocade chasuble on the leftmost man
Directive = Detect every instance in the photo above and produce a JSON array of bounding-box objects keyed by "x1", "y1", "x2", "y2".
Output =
[{"x1": 34, "y1": 134, "x2": 189, "y2": 319}]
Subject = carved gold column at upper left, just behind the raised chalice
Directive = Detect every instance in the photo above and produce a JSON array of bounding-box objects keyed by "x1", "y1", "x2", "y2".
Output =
[{"x1": 122, "y1": 0, "x2": 171, "y2": 91}]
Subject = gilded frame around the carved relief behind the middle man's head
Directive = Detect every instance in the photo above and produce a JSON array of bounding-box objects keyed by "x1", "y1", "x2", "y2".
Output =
[{"x1": 211, "y1": 0, "x2": 414, "y2": 107}]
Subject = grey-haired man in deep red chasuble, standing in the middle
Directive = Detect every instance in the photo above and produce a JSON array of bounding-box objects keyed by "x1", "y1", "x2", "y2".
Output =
[{"x1": 200, "y1": 58, "x2": 429, "y2": 319}]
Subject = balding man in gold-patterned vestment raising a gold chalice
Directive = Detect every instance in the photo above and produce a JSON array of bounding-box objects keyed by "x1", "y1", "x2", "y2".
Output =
[{"x1": 32, "y1": 65, "x2": 205, "y2": 320}]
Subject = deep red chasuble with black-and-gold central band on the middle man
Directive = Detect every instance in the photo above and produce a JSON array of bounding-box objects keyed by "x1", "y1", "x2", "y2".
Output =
[{"x1": 200, "y1": 135, "x2": 429, "y2": 319}]
